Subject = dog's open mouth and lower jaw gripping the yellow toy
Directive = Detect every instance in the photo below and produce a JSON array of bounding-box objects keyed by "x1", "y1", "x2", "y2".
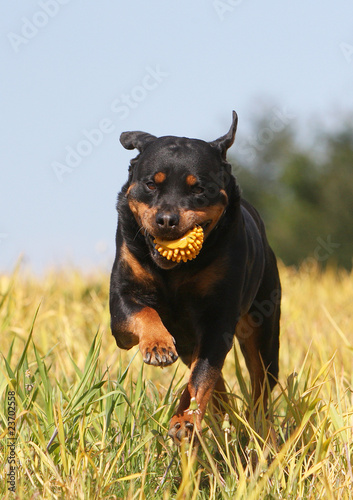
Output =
[{"x1": 145, "y1": 220, "x2": 212, "y2": 269}]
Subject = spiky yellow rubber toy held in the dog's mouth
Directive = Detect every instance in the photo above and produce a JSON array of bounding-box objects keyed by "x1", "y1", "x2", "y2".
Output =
[{"x1": 153, "y1": 226, "x2": 203, "y2": 262}]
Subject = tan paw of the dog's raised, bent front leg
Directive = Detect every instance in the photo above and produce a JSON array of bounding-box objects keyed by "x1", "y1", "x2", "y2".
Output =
[{"x1": 139, "y1": 335, "x2": 178, "y2": 366}]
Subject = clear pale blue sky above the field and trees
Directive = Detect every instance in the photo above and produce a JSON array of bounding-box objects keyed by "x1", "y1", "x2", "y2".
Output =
[{"x1": 0, "y1": 0, "x2": 353, "y2": 273}]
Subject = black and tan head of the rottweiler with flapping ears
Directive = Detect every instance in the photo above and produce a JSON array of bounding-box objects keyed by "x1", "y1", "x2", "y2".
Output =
[{"x1": 120, "y1": 111, "x2": 238, "y2": 269}]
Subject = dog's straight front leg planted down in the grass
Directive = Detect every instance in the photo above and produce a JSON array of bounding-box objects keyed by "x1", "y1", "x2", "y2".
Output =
[{"x1": 169, "y1": 330, "x2": 232, "y2": 444}]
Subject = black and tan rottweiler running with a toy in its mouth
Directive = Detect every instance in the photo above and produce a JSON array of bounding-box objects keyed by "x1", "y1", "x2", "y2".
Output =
[{"x1": 110, "y1": 111, "x2": 281, "y2": 444}]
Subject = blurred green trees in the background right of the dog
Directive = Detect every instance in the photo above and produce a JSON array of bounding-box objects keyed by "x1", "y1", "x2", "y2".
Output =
[{"x1": 233, "y1": 114, "x2": 353, "y2": 269}]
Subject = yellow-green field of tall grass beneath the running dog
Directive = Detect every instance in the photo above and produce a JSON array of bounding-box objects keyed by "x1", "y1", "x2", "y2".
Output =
[{"x1": 0, "y1": 266, "x2": 353, "y2": 500}]
